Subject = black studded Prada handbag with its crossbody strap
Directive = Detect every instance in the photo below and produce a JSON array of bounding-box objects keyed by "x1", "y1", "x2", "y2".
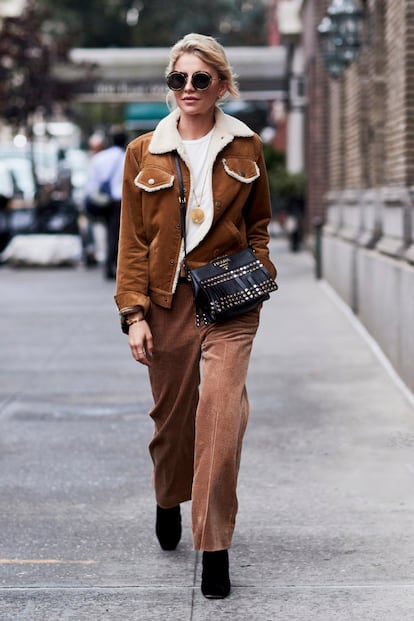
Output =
[{"x1": 175, "y1": 153, "x2": 278, "y2": 325}]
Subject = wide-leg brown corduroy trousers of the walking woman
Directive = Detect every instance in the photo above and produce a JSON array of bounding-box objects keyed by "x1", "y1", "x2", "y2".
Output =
[{"x1": 148, "y1": 284, "x2": 259, "y2": 551}]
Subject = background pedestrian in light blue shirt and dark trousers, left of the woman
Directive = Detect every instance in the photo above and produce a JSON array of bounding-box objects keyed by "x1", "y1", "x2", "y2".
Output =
[{"x1": 85, "y1": 127, "x2": 127, "y2": 279}]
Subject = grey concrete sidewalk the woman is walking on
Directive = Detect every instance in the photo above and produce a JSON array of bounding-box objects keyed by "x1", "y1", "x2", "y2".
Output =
[{"x1": 0, "y1": 240, "x2": 414, "y2": 621}]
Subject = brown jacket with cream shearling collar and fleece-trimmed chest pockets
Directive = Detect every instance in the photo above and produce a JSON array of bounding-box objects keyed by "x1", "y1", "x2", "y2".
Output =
[{"x1": 115, "y1": 108, "x2": 276, "y2": 315}]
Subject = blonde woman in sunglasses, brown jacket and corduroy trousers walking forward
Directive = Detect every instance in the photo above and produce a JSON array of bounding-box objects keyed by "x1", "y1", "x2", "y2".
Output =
[{"x1": 115, "y1": 34, "x2": 276, "y2": 598}]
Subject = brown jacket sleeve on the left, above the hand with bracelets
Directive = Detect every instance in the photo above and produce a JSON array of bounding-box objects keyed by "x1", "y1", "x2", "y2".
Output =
[{"x1": 115, "y1": 140, "x2": 150, "y2": 315}]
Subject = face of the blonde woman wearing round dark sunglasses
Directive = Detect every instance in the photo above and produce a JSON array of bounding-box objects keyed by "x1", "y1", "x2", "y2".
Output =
[{"x1": 172, "y1": 53, "x2": 227, "y2": 121}]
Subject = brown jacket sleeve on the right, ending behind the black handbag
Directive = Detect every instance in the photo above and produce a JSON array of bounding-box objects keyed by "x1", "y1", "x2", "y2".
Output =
[{"x1": 245, "y1": 137, "x2": 277, "y2": 278}]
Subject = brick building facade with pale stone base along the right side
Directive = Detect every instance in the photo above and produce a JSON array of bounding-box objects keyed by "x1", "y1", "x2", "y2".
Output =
[{"x1": 301, "y1": 0, "x2": 414, "y2": 390}]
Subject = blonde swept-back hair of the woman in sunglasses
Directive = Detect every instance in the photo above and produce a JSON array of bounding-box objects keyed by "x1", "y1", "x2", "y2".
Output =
[{"x1": 165, "y1": 32, "x2": 240, "y2": 97}]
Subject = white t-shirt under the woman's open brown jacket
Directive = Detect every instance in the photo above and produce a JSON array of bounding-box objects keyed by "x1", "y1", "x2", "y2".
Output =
[{"x1": 183, "y1": 127, "x2": 214, "y2": 252}]
